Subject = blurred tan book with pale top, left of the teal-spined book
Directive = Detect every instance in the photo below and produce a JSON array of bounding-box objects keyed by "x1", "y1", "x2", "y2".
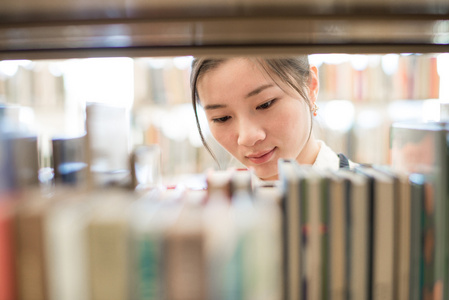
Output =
[{"x1": 87, "y1": 193, "x2": 130, "y2": 300}]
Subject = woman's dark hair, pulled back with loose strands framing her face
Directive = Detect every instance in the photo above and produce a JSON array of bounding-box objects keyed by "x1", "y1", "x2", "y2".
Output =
[{"x1": 190, "y1": 55, "x2": 312, "y2": 163}]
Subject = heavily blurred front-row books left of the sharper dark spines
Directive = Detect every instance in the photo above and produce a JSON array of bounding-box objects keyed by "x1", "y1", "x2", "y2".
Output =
[{"x1": 0, "y1": 171, "x2": 282, "y2": 300}]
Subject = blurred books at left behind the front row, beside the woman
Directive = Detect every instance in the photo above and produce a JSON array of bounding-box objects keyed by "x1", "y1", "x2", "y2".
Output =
[{"x1": 0, "y1": 104, "x2": 214, "y2": 190}]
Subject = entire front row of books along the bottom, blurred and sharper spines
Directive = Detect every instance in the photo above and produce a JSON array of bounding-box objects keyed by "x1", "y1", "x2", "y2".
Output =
[{"x1": 0, "y1": 160, "x2": 449, "y2": 300}]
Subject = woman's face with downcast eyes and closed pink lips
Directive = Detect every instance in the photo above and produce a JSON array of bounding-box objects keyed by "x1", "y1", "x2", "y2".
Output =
[{"x1": 197, "y1": 58, "x2": 318, "y2": 180}]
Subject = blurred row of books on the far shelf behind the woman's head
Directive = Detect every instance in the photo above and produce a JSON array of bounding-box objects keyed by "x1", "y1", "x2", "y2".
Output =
[{"x1": 0, "y1": 54, "x2": 440, "y2": 110}]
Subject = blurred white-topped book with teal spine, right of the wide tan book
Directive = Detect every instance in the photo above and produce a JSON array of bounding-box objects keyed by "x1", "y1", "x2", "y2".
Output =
[{"x1": 129, "y1": 190, "x2": 183, "y2": 300}]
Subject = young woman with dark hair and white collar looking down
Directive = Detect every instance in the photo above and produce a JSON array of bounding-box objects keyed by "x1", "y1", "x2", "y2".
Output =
[{"x1": 191, "y1": 56, "x2": 354, "y2": 180}]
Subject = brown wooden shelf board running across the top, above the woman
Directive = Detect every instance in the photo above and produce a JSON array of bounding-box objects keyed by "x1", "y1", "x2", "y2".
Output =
[{"x1": 0, "y1": 0, "x2": 449, "y2": 59}]
